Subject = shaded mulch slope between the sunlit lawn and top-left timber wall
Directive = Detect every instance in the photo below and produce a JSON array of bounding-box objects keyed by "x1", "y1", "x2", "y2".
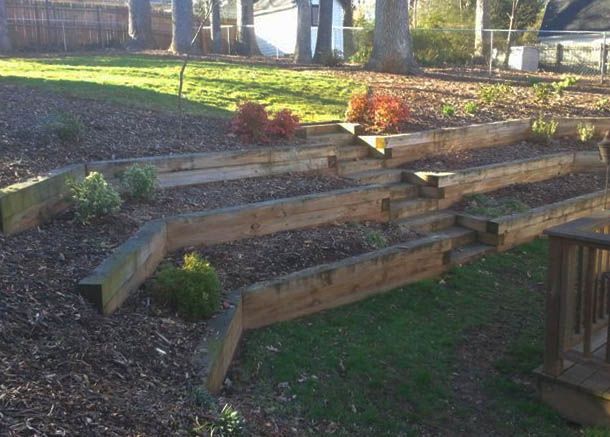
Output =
[{"x1": 0, "y1": 85, "x2": 300, "y2": 187}]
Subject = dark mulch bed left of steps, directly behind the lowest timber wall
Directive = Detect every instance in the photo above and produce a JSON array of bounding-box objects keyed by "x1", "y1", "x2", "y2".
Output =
[{"x1": 157, "y1": 223, "x2": 421, "y2": 291}]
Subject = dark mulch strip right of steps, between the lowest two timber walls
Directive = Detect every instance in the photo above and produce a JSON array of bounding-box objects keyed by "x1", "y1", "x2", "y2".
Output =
[{"x1": 451, "y1": 173, "x2": 605, "y2": 216}]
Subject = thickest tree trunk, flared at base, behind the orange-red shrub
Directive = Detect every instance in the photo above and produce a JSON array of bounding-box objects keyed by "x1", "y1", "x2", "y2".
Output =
[{"x1": 366, "y1": 0, "x2": 419, "y2": 73}]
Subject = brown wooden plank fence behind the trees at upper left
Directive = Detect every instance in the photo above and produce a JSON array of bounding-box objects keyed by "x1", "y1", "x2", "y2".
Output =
[{"x1": 6, "y1": 0, "x2": 235, "y2": 53}]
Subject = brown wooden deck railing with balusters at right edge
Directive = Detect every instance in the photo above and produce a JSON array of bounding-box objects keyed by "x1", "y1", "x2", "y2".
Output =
[{"x1": 544, "y1": 212, "x2": 610, "y2": 376}]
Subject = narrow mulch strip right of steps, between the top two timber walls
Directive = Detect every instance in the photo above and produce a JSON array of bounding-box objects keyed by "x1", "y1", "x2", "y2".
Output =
[{"x1": 403, "y1": 138, "x2": 597, "y2": 171}]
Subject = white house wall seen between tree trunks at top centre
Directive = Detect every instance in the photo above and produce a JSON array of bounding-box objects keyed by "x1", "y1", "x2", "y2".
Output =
[{"x1": 254, "y1": 0, "x2": 343, "y2": 56}]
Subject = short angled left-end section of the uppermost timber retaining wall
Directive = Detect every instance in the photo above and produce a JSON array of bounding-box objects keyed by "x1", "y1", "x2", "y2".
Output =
[{"x1": 0, "y1": 164, "x2": 85, "y2": 235}]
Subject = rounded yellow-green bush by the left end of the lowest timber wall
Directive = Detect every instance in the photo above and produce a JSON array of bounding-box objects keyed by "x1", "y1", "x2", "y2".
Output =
[{"x1": 155, "y1": 253, "x2": 220, "y2": 320}]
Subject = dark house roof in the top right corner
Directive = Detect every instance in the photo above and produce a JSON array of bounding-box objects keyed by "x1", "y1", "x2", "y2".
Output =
[{"x1": 542, "y1": 0, "x2": 610, "y2": 31}]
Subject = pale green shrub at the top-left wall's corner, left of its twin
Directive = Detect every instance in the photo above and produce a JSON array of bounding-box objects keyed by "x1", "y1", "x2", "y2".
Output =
[{"x1": 70, "y1": 172, "x2": 121, "y2": 224}]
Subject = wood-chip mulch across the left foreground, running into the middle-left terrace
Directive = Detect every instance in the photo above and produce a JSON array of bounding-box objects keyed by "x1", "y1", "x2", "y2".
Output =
[{"x1": 0, "y1": 174, "x2": 353, "y2": 435}]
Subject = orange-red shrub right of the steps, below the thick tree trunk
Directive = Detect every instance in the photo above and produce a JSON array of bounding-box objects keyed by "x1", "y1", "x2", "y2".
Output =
[{"x1": 345, "y1": 93, "x2": 410, "y2": 133}]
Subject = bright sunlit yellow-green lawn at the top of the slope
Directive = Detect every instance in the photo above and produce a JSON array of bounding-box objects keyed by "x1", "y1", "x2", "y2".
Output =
[{"x1": 0, "y1": 56, "x2": 356, "y2": 122}]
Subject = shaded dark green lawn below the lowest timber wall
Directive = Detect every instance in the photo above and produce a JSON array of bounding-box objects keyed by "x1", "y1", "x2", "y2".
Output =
[{"x1": 233, "y1": 241, "x2": 609, "y2": 436}]
